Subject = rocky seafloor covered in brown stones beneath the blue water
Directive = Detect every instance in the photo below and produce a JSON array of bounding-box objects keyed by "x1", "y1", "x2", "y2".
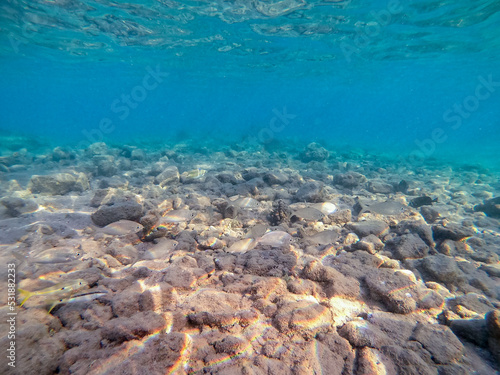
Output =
[{"x1": 0, "y1": 143, "x2": 500, "y2": 375}]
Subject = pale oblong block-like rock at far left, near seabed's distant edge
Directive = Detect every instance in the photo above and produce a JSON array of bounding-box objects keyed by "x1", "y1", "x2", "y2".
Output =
[{"x1": 28, "y1": 173, "x2": 90, "y2": 195}]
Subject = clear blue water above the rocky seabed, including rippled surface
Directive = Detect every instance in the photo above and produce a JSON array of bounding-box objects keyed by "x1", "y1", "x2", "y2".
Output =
[{"x1": 0, "y1": 0, "x2": 500, "y2": 168}]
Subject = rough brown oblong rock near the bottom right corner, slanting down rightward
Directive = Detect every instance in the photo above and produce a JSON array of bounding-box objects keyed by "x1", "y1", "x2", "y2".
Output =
[{"x1": 412, "y1": 324, "x2": 464, "y2": 364}]
